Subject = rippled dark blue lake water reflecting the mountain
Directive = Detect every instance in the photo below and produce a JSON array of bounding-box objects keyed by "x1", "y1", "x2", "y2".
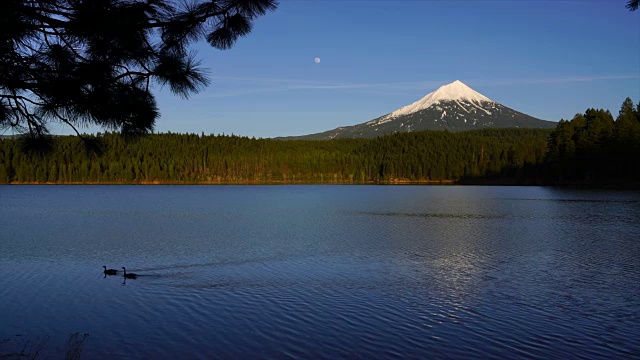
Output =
[{"x1": 0, "y1": 186, "x2": 640, "y2": 359}]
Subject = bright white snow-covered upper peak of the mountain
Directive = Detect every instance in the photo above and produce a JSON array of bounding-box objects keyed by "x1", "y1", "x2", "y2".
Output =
[{"x1": 388, "y1": 80, "x2": 494, "y2": 118}]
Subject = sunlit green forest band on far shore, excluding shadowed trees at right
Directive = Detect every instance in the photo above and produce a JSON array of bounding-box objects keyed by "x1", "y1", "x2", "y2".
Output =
[{"x1": 0, "y1": 129, "x2": 550, "y2": 184}]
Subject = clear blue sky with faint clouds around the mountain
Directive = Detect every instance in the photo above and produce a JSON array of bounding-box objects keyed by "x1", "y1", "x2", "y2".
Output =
[{"x1": 65, "y1": 0, "x2": 640, "y2": 137}]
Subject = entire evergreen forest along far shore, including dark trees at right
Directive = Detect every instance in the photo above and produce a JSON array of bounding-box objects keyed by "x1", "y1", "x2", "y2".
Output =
[{"x1": 0, "y1": 99, "x2": 640, "y2": 184}]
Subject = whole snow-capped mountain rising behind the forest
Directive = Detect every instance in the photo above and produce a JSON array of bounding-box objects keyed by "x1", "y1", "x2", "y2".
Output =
[{"x1": 288, "y1": 80, "x2": 557, "y2": 140}]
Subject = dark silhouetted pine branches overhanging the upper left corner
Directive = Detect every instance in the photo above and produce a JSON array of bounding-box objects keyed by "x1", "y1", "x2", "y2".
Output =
[{"x1": 0, "y1": 0, "x2": 278, "y2": 138}]
